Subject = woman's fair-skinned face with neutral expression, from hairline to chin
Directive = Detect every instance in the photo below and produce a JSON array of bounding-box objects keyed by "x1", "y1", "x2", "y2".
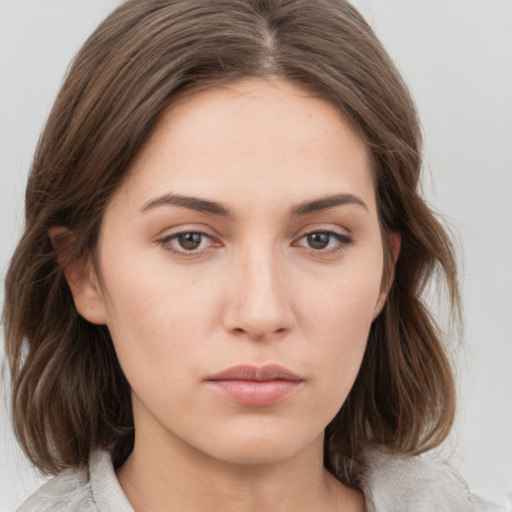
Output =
[{"x1": 72, "y1": 80, "x2": 384, "y2": 463}]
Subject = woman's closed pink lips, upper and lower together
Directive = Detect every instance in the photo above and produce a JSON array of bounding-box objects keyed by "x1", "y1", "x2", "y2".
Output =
[{"x1": 206, "y1": 365, "x2": 304, "y2": 407}]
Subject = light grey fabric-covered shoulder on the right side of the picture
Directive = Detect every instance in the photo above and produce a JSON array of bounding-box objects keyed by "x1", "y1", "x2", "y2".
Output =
[{"x1": 362, "y1": 451, "x2": 499, "y2": 512}]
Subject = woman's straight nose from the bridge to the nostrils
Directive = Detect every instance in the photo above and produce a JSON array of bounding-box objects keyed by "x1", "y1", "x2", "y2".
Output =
[{"x1": 224, "y1": 246, "x2": 295, "y2": 341}]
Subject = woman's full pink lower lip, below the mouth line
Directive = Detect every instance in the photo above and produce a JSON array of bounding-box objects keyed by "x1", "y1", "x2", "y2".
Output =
[{"x1": 208, "y1": 379, "x2": 302, "y2": 406}]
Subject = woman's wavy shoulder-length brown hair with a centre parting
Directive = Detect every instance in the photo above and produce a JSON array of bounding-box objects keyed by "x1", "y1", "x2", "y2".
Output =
[{"x1": 4, "y1": 0, "x2": 460, "y2": 486}]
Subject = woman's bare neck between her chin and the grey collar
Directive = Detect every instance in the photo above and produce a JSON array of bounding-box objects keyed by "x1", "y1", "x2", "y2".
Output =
[{"x1": 118, "y1": 426, "x2": 364, "y2": 512}]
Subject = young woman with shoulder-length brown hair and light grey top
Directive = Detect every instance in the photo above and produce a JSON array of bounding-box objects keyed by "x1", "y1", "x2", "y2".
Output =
[{"x1": 5, "y1": 0, "x2": 502, "y2": 511}]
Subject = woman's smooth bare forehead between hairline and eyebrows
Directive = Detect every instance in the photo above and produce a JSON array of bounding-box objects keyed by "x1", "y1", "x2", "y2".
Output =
[{"x1": 113, "y1": 79, "x2": 374, "y2": 216}]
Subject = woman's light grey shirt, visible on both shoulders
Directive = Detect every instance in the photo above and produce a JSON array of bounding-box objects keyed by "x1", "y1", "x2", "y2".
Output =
[{"x1": 17, "y1": 451, "x2": 500, "y2": 512}]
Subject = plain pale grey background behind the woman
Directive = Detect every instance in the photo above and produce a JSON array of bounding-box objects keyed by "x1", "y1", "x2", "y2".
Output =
[{"x1": 0, "y1": 0, "x2": 512, "y2": 512}]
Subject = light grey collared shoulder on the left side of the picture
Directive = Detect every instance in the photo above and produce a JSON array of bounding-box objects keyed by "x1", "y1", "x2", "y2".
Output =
[{"x1": 16, "y1": 451, "x2": 133, "y2": 512}]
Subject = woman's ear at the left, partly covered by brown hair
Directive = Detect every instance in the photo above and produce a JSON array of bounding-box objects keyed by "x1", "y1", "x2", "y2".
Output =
[{"x1": 48, "y1": 226, "x2": 107, "y2": 324}]
